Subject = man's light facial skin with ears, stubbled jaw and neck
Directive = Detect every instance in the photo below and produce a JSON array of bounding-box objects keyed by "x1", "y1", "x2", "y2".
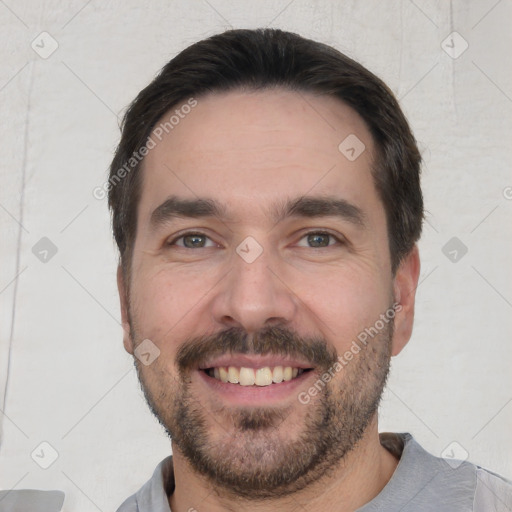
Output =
[{"x1": 118, "y1": 89, "x2": 419, "y2": 512}]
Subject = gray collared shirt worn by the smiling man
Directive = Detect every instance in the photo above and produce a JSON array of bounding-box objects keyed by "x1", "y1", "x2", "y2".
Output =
[{"x1": 117, "y1": 434, "x2": 512, "y2": 512}]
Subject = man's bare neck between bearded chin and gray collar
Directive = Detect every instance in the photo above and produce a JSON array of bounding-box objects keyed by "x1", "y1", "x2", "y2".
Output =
[{"x1": 169, "y1": 416, "x2": 398, "y2": 512}]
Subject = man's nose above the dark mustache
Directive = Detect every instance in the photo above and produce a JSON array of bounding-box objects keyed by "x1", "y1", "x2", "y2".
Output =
[{"x1": 212, "y1": 244, "x2": 298, "y2": 332}]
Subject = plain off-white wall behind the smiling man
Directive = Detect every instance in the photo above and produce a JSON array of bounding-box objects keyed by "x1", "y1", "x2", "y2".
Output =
[{"x1": 0, "y1": 0, "x2": 512, "y2": 512}]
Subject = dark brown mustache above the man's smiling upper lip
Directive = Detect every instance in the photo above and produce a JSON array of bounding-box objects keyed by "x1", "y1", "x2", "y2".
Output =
[{"x1": 176, "y1": 326, "x2": 338, "y2": 375}]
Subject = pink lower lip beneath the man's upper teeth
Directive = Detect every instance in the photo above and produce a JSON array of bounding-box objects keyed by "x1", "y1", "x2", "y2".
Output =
[{"x1": 196, "y1": 370, "x2": 315, "y2": 406}]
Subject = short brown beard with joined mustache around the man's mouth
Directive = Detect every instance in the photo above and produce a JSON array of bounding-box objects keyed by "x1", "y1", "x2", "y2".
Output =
[{"x1": 130, "y1": 310, "x2": 393, "y2": 500}]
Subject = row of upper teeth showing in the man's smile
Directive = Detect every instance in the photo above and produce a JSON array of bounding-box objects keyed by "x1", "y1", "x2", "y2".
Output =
[{"x1": 208, "y1": 366, "x2": 304, "y2": 386}]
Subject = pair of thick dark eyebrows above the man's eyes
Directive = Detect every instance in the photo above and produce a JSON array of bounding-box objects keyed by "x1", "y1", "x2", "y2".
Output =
[{"x1": 150, "y1": 196, "x2": 366, "y2": 230}]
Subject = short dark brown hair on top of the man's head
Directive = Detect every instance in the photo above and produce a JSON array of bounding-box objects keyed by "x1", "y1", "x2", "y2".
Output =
[{"x1": 108, "y1": 29, "x2": 423, "y2": 275}]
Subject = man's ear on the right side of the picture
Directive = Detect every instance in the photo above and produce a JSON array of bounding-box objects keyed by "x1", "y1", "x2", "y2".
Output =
[{"x1": 391, "y1": 244, "x2": 420, "y2": 356}]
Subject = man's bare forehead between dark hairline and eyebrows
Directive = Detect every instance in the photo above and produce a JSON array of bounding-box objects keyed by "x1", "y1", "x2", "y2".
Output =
[{"x1": 139, "y1": 89, "x2": 378, "y2": 220}]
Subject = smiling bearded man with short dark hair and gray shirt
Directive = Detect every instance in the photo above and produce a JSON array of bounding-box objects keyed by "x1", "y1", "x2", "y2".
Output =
[{"x1": 108, "y1": 30, "x2": 512, "y2": 512}]
